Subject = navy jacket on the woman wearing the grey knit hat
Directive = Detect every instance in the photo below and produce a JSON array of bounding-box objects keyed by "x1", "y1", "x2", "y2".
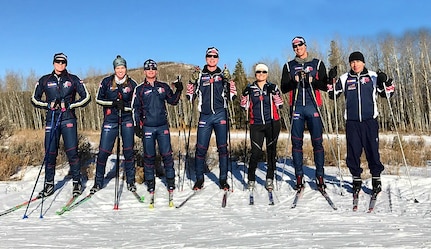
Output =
[{"x1": 96, "y1": 75, "x2": 137, "y2": 123}]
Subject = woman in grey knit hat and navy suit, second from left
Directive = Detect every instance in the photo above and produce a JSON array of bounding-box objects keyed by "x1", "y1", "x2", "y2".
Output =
[{"x1": 90, "y1": 55, "x2": 137, "y2": 194}]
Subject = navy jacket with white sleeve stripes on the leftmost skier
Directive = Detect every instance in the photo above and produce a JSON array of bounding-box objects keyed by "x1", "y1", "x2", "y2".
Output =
[{"x1": 31, "y1": 70, "x2": 91, "y2": 120}]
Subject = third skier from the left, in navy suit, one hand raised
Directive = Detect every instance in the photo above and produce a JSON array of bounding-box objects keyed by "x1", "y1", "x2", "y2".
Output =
[{"x1": 132, "y1": 59, "x2": 183, "y2": 193}]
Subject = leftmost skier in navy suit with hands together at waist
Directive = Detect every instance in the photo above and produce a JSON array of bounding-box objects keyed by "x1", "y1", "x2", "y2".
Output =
[{"x1": 31, "y1": 53, "x2": 90, "y2": 198}]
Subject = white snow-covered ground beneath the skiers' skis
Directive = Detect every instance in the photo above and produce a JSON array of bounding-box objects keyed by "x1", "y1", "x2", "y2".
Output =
[{"x1": 0, "y1": 157, "x2": 431, "y2": 248}]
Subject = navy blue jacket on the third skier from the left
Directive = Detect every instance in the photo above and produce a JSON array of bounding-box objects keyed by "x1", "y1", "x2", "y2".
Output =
[{"x1": 132, "y1": 79, "x2": 181, "y2": 127}]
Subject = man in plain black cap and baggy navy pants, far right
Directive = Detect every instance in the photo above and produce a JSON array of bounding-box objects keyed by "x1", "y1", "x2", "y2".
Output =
[{"x1": 328, "y1": 51, "x2": 395, "y2": 204}]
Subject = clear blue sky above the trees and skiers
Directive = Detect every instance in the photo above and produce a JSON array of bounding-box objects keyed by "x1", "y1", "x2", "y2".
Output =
[{"x1": 0, "y1": 0, "x2": 431, "y2": 81}]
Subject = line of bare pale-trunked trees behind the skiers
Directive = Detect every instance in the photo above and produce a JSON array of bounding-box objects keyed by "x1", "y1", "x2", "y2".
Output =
[{"x1": 0, "y1": 30, "x2": 431, "y2": 134}]
